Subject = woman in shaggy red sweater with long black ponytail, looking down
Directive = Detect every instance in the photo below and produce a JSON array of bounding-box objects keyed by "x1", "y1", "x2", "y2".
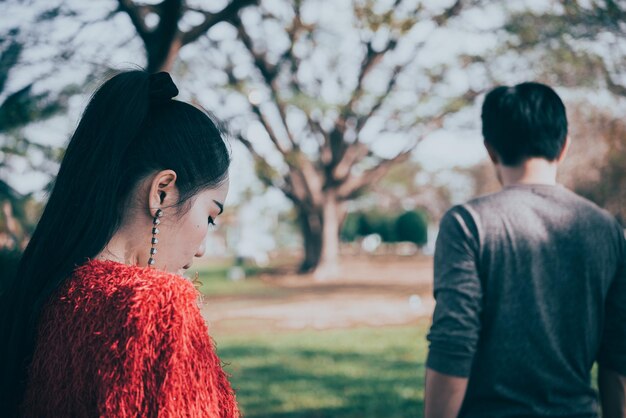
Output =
[{"x1": 0, "y1": 71, "x2": 239, "y2": 417}]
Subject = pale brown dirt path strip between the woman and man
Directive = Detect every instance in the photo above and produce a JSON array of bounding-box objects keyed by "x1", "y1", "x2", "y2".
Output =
[{"x1": 202, "y1": 258, "x2": 434, "y2": 334}]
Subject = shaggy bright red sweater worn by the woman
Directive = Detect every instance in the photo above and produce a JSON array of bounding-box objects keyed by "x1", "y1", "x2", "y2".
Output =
[{"x1": 23, "y1": 260, "x2": 239, "y2": 418}]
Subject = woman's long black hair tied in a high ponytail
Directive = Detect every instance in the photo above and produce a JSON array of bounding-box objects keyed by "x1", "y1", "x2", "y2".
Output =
[{"x1": 0, "y1": 70, "x2": 230, "y2": 416}]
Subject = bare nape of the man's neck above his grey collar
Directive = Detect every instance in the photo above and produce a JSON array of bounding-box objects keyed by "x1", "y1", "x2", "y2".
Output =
[{"x1": 496, "y1": 158, "x2": 557, "y2": 187}]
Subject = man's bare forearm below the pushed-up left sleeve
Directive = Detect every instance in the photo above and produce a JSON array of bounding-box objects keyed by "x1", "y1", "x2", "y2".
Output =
[{"x1": 424, "y1": 368, "x2": 468, "y2": 418}]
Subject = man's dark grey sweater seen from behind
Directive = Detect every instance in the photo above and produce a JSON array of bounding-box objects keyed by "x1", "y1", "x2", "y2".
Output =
[{"x1": 428, "y1": 185, "x2": 626, "y2": 417}]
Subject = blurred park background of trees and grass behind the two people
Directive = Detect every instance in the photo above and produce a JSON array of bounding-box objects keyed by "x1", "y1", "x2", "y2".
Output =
[{"x1": 0, "y1": 0, "x2": 626, "y2": 417}]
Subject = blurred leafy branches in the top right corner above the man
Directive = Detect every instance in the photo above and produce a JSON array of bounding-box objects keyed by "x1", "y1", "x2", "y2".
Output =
[{"x1": 504, "y1": 0, "x2": 626, "y2": 97}]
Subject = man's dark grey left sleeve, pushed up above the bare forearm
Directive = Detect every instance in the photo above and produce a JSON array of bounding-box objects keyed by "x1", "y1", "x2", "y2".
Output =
[{"x1": 426, "y1": 206, "x2": 482, "y2": 377}]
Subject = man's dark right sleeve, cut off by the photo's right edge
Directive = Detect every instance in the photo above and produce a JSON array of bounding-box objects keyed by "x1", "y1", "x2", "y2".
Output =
[{"x1": 598, "y1": 227, "x2": 626, "y2": 376}]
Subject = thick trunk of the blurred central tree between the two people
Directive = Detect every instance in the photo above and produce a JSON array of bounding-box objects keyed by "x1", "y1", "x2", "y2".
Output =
[{"x1": 297, "y1": 191, "x2": 345, "y2": 280}]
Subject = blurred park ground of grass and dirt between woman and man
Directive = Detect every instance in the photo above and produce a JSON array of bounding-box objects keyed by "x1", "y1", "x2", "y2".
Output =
[{"x1": 198, "y1": 256, "x2": 434, "y2": 418}]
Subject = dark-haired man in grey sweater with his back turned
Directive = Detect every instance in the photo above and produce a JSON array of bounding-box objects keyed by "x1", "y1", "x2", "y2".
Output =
[{"x1": 425, "y1": 83, "x2": 626, "y2": 418}]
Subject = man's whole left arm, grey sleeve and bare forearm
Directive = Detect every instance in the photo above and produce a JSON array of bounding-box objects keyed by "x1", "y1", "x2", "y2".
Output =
[{"x1": 424, "y1": 207, "x2": 482, "y2": 418}]
